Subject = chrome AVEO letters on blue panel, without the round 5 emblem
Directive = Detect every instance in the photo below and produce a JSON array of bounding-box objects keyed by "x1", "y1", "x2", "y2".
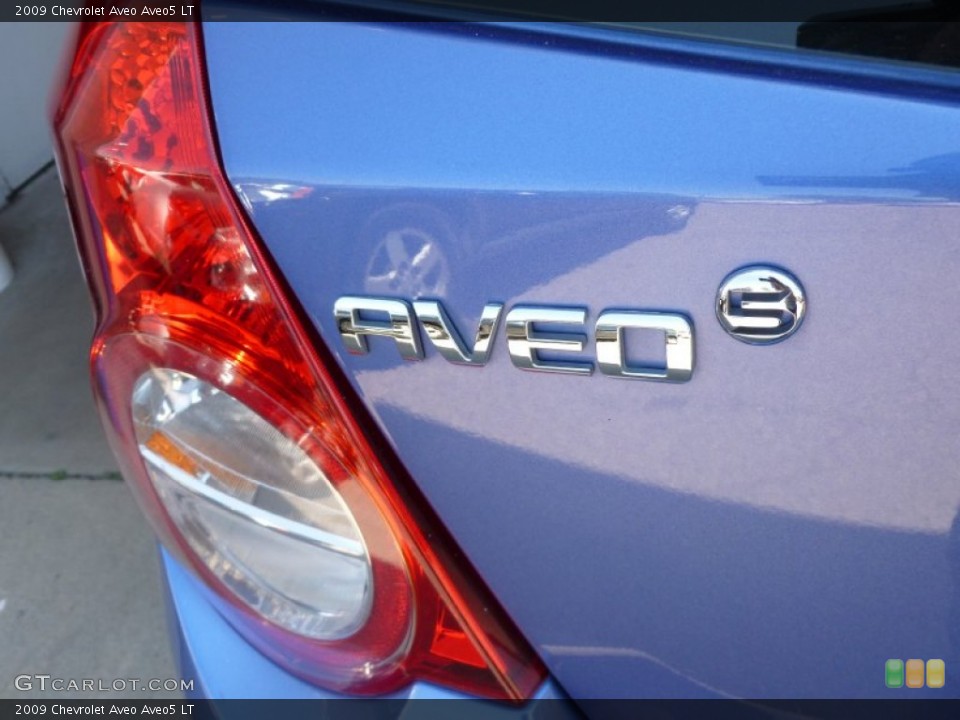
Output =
[{"x1": 334, "y1": 295, "x2": 694, "y2": 382}]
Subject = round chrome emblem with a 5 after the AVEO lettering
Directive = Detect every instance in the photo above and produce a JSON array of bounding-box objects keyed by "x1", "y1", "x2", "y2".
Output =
[{"x1": 717, "y1": 265, "x2": 807, "y2": 345}]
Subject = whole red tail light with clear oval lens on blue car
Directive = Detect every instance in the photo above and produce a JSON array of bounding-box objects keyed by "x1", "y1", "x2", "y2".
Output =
[{"x1": 54, "y1": 22, "x2": 543, "y2": 699}]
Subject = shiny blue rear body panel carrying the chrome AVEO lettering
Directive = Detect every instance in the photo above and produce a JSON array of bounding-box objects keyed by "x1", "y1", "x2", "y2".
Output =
[{"x1": 197, "y1": 19, "x2": 960, "y2": 698}]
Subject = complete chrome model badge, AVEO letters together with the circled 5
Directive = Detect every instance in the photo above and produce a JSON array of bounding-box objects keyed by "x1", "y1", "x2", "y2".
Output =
[{"x1": 333, "y1": 265, "x2": 807, "y2": 382}]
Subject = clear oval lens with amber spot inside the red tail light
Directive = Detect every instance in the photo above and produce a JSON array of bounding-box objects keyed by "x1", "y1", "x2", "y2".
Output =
[{"x1": 132, "y1": 368, "x2": 374, "y2": 640}]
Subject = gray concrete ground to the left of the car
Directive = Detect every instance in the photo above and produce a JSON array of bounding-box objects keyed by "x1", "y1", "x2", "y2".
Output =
[{"x1": 0, "y1": 170, "x2": 182, "y2": 699}]
